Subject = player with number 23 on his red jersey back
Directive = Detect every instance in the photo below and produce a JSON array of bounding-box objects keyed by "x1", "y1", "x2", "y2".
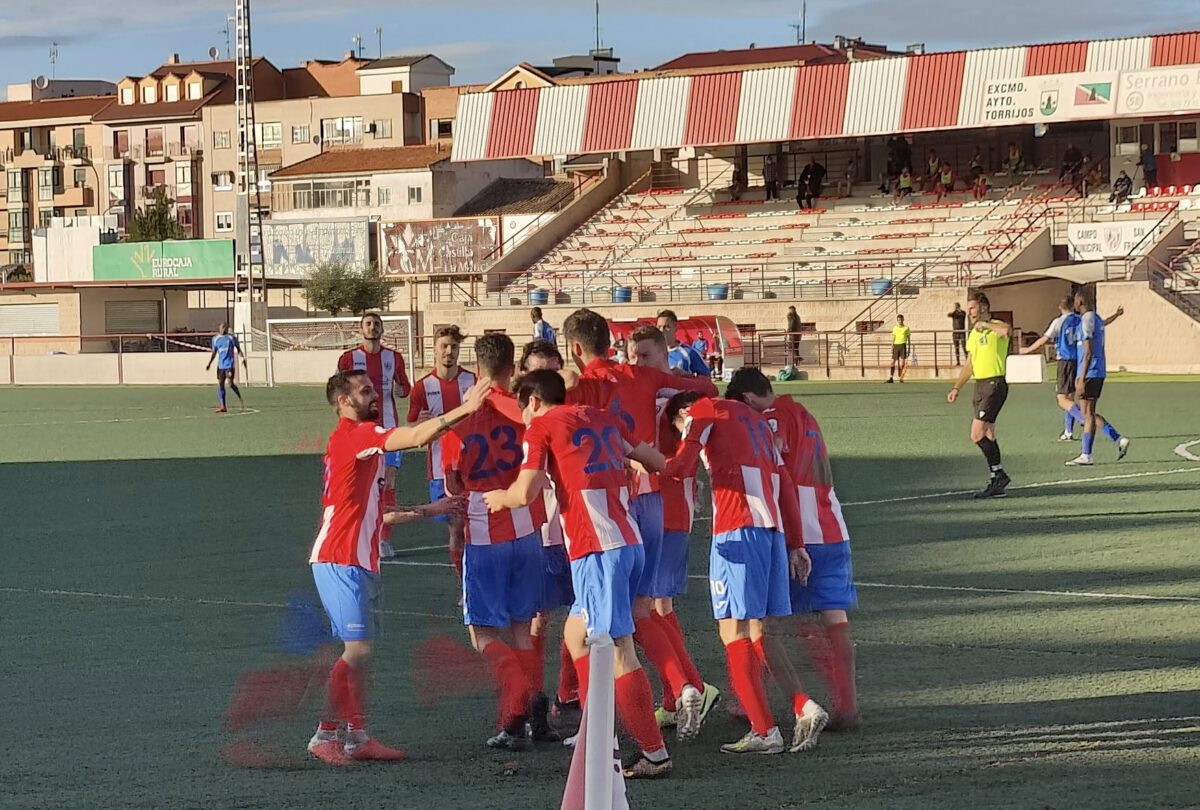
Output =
[{"x1": 443, "y1": 334, "x2": 557, "y2": 750}]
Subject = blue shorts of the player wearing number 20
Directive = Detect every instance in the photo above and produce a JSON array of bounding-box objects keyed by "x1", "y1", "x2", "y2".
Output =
[{"x1": 571, "y1": 546, "x2": 644, "y2": 640}]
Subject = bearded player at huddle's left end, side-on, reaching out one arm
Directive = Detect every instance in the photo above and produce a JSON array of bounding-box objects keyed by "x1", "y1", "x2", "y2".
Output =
[{"x1": 308, "y1": 370, "x2": 487, "y2": 764}]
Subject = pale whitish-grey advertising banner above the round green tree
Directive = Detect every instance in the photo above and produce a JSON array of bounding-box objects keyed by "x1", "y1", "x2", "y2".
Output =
[{"x1": 263, "y1": 218, "x2": 371, "y2": 278}]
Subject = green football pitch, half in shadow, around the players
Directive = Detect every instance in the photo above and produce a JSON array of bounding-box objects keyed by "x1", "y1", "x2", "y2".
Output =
[{"x1": 0, "y1": 379, "x2": 1200, "y2": 810}]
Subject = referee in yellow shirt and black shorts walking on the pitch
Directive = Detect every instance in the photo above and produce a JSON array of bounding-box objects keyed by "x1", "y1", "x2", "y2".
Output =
[{"x1": 946, "y1": 293, "x2": 1013, "y2": 498}]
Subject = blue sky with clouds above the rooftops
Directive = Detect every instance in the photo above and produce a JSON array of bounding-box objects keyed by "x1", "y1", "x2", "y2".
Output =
[{"x1": 0, "y1": 0, "x2": 1200, "y2": 96}]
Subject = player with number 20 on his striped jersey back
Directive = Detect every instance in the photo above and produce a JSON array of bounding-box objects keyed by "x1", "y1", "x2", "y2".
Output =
[{"x1": 484, "y1": 371, "x2": 671, "y2": 778}]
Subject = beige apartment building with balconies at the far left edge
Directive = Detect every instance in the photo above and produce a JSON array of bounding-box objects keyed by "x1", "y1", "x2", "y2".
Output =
[{"x1": 0, "y1": 94, "x2": 113, "y2": 266}]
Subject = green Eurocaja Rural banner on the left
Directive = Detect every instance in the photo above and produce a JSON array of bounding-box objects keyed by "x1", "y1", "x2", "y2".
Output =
[{"x1": 91, "y1": 239, "x2": 233, "y2": 281}]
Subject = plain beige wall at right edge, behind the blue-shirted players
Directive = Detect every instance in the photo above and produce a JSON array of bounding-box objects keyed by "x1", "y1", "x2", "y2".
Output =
[{"x1": 1096, "y1": 281, "x2": 1200, "y2": 374}]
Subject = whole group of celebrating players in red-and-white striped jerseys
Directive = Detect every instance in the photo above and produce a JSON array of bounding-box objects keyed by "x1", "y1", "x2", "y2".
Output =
[{"x1": 308, "y1": 310, "x2": 858, "y2": 778}]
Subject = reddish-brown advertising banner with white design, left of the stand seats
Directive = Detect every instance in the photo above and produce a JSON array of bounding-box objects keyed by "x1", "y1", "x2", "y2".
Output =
[{"x1": 379, "y1": 217, "x2": 500, "y2": 276}]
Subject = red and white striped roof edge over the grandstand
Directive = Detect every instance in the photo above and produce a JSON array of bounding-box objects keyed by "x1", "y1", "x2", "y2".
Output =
[{"x1": 452, "y1": 32, "x2": 1200, "y2": 161}]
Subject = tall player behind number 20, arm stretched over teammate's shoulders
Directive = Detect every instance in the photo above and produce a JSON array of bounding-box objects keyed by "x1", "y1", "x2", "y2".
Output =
[{"x1": 563, "y1": 310, "x2": 716, "y2": 740}]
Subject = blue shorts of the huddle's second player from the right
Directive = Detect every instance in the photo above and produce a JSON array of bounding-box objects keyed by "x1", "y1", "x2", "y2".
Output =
[{"x1": 708, "y1": 528, "x2": 792, "y2": 619}]
